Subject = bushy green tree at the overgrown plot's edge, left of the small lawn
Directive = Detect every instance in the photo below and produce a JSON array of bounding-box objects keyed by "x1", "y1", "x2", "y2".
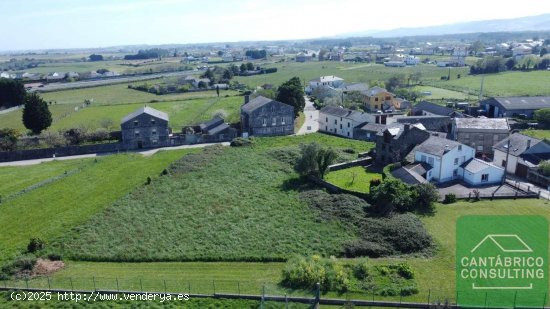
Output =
[{"x1": 294, "y1": 143, "x2": 338, "y2": 178}]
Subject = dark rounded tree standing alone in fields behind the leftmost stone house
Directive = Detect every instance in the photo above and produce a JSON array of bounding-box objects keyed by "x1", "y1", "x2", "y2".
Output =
[{"x1": 23, "y1": 92, "x2": 52, "y2": 134}]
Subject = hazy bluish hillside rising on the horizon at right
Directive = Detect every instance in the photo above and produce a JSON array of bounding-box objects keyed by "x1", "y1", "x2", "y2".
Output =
[{"x1": 338, "y1": 13, "x2": 550, "y2": 38}]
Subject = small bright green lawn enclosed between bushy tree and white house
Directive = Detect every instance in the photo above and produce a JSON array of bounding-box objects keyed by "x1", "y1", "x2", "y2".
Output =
[{"x1": 325, "y1": 166, "x2": 382, "y2": 193}]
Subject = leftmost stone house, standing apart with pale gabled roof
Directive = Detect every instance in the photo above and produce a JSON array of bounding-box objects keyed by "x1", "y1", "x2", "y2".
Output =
[{"x1": 120, "y1": 106, "x2": 169, "y2": 149}]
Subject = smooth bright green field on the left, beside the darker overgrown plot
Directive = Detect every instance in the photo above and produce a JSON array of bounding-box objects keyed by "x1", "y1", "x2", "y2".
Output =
[{"x1": 0, "y1": 150, "x2": 196, "y2": 261}]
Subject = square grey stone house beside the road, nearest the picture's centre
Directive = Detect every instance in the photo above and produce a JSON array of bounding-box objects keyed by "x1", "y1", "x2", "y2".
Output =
[{"x1": 241, "y1": 96, "x2": 294, "y2": 137}]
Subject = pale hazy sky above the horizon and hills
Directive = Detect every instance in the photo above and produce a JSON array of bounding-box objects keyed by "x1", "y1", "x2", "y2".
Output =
[{"x1": 0, "y1": 0, "x2": 550, "y2": 51}]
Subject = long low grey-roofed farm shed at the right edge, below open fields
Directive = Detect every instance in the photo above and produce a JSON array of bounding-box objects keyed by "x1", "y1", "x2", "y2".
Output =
[{"x1": 480, "y1": 96, "x2": 550, "y2": 118}]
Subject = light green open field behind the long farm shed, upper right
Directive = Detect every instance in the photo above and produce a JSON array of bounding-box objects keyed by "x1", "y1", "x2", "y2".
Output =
[{"x1": 433, "y1": 71, "x2": 550, "y2": 97}]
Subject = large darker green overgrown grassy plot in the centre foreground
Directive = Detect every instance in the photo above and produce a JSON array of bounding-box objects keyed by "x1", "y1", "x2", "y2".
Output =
[{"x1": 54, "y1": 143, "x2": 355, "y2": 261}]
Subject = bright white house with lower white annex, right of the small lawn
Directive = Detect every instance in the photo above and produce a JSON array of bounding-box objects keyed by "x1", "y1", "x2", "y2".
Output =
[{"x1": 409, "y1": 136, "x2": 504, "y2": 185}]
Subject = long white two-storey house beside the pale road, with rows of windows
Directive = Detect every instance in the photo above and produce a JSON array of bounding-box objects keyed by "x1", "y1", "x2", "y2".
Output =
[{"x1": 319, "y1": 106, "x2": 369, "y2": 138}]
